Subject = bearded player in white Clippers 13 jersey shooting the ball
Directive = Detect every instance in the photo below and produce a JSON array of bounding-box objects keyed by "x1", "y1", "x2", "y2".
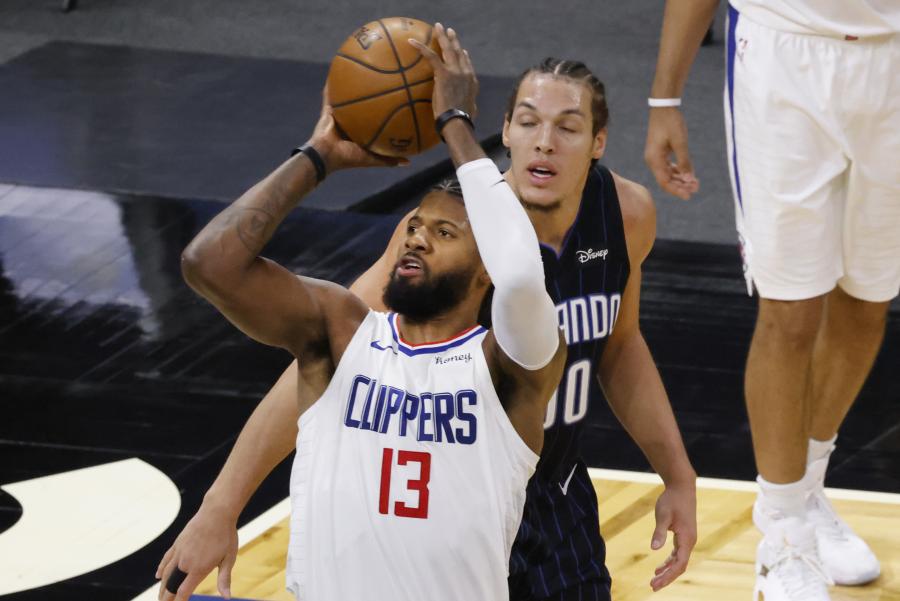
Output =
[{"x1": 154, "y1": 26, "x2": 566, "y2": 601}]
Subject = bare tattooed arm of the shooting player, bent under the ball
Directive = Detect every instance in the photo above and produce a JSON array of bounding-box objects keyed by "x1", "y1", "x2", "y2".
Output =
[{"x1": 182, "y1": 94, "x2": 400, "y2": 357}]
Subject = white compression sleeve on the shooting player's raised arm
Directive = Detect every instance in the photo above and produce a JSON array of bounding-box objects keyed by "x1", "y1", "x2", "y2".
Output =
[{"x1": 456, "y1": 158, "x2": 559, "y2": 370}]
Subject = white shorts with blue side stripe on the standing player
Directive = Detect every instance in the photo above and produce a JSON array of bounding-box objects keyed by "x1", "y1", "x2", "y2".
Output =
[{"x1": 725, "y1": 8, "x2": 900, "y2": 302}]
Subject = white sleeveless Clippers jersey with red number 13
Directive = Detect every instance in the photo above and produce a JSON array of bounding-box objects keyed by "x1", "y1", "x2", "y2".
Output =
[{"x1": 287, "y1": 311, "x2": 538, "y2": 601}]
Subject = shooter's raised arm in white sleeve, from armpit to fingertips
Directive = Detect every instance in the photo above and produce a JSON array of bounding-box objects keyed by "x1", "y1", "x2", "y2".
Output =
[{"x1": 414, "y1": 24, "x2": 566, "y2": 452}]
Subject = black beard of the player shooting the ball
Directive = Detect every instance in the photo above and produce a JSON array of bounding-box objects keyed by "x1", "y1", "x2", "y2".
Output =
[{"x1": 382, "y1": 268, "x2": 474, "y2": 323}]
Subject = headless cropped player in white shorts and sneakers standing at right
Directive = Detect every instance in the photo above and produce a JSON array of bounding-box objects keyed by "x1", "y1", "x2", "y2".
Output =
[{"x1": 645, "y1": 0, "x2": 900, "y2": 601}]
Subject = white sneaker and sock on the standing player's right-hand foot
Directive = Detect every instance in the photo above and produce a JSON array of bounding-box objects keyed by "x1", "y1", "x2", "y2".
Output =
[{"x1": 806, "y1": 457, "x2": 881, "y2": 586}]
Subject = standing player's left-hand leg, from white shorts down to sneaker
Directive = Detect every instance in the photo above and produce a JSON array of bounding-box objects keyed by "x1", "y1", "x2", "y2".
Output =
[{"x1": 725, "y1": 8, "x2": 849, "y2": 601}]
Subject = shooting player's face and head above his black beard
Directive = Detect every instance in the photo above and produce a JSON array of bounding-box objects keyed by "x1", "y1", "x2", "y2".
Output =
[{"x1": 391, "y1": 192, "x2": 483, "y2": 286}]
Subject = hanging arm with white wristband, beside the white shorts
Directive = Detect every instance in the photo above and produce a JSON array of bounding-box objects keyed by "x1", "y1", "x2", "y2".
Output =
[{"x1": 644, "y1": 0, "x2": 719, "y2": 200}]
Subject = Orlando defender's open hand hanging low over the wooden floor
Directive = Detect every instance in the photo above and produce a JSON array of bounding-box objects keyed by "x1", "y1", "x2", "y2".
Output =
[{"x1": 650, "y1": 486, "x2": 697, "y2": 591}]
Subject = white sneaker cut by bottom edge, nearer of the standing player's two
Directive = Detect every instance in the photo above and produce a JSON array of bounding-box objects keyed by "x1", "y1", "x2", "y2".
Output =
[{"x1": 753, "y1": 518, "x2": 833, "y2": 601}]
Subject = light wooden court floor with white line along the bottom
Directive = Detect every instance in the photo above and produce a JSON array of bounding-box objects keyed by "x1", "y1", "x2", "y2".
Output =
[{"x1": 197, "y1": 470, "x2": 900, "y2": 601}]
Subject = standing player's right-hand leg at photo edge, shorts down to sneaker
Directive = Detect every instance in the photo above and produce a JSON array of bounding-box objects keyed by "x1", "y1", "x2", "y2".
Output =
[{"x1": 808, "y1": 30, "x2": 900, "y2": 584}]
